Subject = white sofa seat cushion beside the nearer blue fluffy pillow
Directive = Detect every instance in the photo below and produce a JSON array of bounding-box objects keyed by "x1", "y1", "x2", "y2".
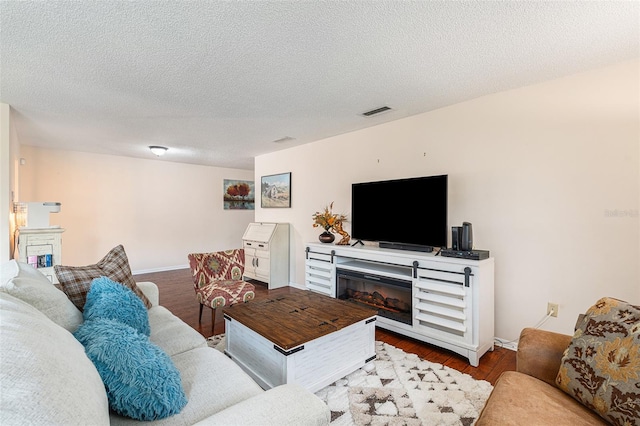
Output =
[{"x1": 111, "y1": 347, "x2": 264, "y2": 425}]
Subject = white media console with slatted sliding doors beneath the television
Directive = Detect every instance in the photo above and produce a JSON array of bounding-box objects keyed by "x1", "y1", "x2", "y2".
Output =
[{"x1": 305, "y1": 243, "x2": 494, "y2": 367}]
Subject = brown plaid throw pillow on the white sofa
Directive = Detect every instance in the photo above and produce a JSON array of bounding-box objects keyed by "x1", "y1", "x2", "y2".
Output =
[{"x1": 53, "y1": 245, "x2": 151, "y2": 311}]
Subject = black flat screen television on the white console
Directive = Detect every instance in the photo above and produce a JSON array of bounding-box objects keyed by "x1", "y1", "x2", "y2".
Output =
[{"x1": 351, "y1": 175, "x2": 448, "y2": 252}]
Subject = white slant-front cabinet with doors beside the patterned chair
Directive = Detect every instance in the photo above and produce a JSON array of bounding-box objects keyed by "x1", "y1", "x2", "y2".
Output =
[{"x1": 242, "y1": 223, "x2": 289, "y2": 289}]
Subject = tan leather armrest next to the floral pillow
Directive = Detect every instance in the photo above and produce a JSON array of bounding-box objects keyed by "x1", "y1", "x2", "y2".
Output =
[{"x1": 516, "y1": 328, "x2": 572, "y2": 386}]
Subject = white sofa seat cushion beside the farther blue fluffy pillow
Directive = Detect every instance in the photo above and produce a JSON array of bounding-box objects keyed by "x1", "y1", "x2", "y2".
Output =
[{"x1": 147, "y1": 306, "x2": 207, "y2": 356}]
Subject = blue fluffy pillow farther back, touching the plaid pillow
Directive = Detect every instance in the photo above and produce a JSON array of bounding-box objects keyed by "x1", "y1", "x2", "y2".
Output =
[{"x1": 82, "y1": 277, "x2": 151, "y2": 336}]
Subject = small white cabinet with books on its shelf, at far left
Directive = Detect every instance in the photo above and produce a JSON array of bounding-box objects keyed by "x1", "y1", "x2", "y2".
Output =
[{"x1": 16, "y1": 228, "x2": 64, "y2": 284}]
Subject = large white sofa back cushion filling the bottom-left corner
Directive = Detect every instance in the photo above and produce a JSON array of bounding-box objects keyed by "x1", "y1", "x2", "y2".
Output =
[{"x1": 0, "y1": 292, "x2": 109, "y2": 426}]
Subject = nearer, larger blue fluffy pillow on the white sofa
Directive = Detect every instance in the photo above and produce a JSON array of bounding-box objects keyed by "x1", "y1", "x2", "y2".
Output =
[{"x1": 74, "y1": 318, "x2": 187, "y2": 421}]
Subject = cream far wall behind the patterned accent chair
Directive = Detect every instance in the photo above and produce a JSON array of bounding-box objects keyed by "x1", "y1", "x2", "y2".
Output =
[{"x1": 19, "y1": 146, "x2": 254, "y2": 273}]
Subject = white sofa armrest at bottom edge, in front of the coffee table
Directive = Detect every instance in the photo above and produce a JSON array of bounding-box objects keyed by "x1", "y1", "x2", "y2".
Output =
[{"x1": 196, "y1": 384, "x2": 331, "y2": 426}]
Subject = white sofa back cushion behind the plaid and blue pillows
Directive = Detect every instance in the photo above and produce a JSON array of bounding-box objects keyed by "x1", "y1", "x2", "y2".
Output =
[{"x1": 0, "y1": 260, "x2": 82, "y2": 333}]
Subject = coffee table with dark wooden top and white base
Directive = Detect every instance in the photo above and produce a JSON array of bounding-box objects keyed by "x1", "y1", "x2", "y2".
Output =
[{"x1": 224, "y1": 289, "x2": 377, "y2": 392}]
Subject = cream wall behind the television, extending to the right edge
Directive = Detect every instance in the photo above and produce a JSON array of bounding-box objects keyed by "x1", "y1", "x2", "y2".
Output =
[{"x1": 255, "y1": 61, "x2": 640, "y2": 339}]
